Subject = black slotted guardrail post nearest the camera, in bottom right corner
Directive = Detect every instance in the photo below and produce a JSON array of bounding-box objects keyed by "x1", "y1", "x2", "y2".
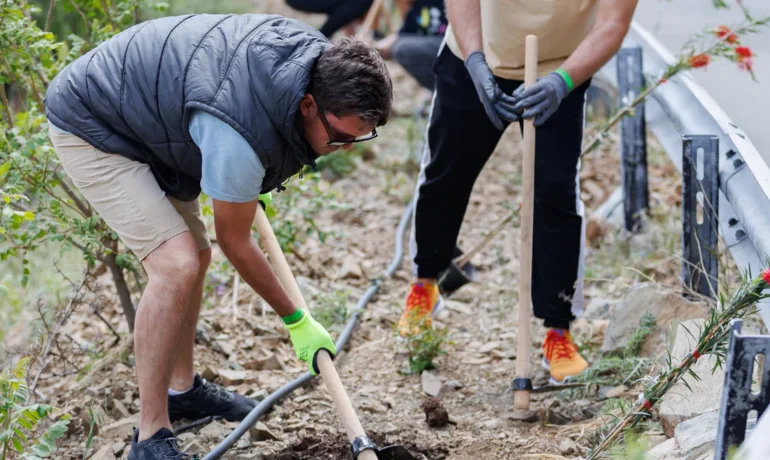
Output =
[{"x1": 714, "y1": 319, "x2": 770, "y2": 460}]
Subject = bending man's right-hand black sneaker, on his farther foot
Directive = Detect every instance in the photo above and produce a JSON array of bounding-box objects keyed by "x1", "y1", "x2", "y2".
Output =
[{"x1": 168, "y1": 374, "x2": 257, "y2": 423}]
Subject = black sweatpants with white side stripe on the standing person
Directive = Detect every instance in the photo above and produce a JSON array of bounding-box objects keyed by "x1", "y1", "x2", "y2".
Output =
[{"x1": 411, "y1": 46, "x2": 589, "y2": 328}]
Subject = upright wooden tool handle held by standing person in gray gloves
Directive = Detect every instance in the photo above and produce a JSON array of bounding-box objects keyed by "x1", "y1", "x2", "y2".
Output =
[{"x1": 513, "y1": 35, "x2": 537, "y2": 410}]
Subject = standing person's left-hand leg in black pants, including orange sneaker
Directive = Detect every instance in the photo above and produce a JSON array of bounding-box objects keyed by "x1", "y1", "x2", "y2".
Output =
[{"x1": 399, "y1": 46, "x2": 503, "y2": 336}]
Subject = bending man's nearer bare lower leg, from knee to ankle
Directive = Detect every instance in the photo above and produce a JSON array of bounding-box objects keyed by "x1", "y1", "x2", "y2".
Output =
[{"x1": 134, "y1": 232, "x2": 200, "y2": 441}]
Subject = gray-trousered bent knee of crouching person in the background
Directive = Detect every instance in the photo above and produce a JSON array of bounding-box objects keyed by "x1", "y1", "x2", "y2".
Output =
[{"x1": 390, "y1": 34, "x2": 444, "y2": 91}]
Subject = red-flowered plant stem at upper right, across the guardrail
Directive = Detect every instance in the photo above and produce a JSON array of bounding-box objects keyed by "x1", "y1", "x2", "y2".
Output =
[{"x1": 581, "y1": 10, "x2": 770, "y2": 156}]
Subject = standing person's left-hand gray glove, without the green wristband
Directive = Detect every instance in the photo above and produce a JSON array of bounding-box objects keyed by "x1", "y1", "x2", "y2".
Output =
[{"x1": 465, "y1": 51, "x2": 519, "y2": 131}]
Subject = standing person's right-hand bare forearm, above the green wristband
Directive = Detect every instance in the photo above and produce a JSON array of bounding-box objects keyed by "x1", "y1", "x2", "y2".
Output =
[{"x1": 560, "y1": 0, "x2": 638, "y2": 87}]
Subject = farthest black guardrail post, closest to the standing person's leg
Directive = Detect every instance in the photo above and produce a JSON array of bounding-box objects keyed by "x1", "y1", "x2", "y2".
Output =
[{"x1": 617, "y1": 46, "x2": 649, "y2": 233}]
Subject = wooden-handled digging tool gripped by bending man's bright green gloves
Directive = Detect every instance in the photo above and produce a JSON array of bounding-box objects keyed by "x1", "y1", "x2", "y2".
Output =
[{"x1": 254, "y1": 206, "x2": 417, "y2": 460}]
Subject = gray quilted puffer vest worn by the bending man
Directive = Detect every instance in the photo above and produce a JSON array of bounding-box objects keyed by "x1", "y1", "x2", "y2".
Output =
[{"x1": 45, "y1": 14, "x2": 330, "y2": 201}]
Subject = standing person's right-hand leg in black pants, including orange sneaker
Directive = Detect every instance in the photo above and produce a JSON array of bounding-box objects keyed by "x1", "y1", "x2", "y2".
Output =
[{"x1": 532, "y1": 81, "x2": 590, "y2": 383}]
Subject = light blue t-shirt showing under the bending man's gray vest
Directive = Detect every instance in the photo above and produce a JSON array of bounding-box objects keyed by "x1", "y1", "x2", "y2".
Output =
[{"x1": 48, "y1": 110, "x2": 265, "y2": 203}]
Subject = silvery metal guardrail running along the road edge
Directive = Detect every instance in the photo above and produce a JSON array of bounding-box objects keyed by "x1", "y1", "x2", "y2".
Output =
[{"x1": 595, "y1": 23, "x2": 770, "y2": 329}]
